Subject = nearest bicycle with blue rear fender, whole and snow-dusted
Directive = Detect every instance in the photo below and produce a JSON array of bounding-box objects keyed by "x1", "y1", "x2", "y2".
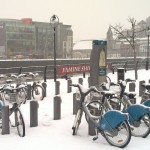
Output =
[{"x1": 70, "y1": 84, "x2": 131, "y2": 148}]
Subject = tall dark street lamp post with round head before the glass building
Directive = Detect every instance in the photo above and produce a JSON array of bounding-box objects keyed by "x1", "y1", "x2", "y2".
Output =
[{"x1": 50, "y1": 15, "x2": 59, "y2": 82}]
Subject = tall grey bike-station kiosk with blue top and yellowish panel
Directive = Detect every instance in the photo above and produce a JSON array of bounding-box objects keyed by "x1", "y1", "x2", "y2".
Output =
[{"x1": 88, "y1": 40, "x2": 107, "y2": 136}]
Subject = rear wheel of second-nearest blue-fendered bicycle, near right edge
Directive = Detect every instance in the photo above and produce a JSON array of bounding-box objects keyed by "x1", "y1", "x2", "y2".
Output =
[{"x1": 130, "y1": 114, "x2": 150, "y2": 138}]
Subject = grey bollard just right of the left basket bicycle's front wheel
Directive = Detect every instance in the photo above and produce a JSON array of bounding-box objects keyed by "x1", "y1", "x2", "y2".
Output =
[{"x1": 30, "y1": 100, "x2": 39, "y2": 127}]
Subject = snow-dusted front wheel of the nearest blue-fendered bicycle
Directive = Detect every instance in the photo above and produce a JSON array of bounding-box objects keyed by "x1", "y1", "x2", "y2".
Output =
[{"x1": 72, "y1": 109, "x2": 83, "y2": 135}]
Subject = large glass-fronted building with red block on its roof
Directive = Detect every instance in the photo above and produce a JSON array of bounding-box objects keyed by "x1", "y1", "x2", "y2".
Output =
[{"x1": 0, "y1": 18, "x2": 73, "y2": 59}]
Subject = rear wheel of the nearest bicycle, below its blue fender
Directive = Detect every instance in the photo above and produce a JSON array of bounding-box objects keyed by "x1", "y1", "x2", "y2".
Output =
[{"x1": 103, "y1": 121, "x2": 131, "y2": 148}]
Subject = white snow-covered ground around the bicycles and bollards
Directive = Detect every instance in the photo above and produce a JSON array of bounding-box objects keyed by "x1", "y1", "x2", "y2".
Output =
[{"x1": 0, "y1": 70, "x2": 150, "y2": 150}]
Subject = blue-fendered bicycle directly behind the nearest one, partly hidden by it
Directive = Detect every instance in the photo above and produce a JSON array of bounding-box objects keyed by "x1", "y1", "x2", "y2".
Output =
[{"x1": 107, "y1": 79, "x2": 150, "y2": 138}]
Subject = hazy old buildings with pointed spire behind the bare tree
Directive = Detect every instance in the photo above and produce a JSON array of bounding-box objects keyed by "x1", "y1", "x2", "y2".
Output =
[{"x1": 107, "y1": 17, "x2": 150, "y2": 58}]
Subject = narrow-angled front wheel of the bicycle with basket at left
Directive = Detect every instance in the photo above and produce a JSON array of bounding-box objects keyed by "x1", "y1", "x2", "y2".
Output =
[{"x1": 14, "y1": 108, "x2": 25, "y2": 137}]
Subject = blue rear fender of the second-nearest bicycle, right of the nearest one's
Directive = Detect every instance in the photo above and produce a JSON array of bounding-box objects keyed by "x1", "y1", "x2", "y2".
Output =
[{"x1": 126, "y1": 104, "x2": 150, "y2": 123}]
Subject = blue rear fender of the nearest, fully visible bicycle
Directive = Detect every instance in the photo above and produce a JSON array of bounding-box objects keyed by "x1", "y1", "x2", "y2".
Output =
[{"x1": 98, "y1": 110, "x2": 128, "y2": 131}]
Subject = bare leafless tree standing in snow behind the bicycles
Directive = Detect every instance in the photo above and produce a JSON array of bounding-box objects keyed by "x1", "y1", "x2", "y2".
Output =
[{"x1": 110, "y1": 17, "x2": 138, "y2": 80}]
